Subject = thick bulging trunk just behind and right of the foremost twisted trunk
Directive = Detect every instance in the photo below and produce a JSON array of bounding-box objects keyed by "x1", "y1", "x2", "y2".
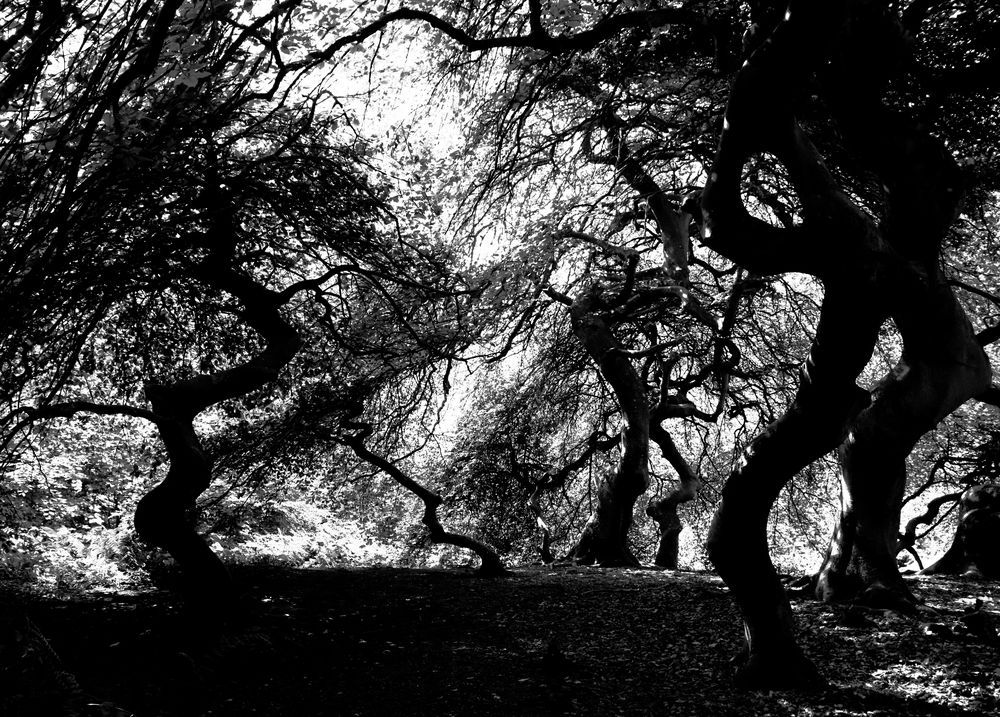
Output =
[{"x1": 817, "y1": 2, "x2": 991, "y2": 610}]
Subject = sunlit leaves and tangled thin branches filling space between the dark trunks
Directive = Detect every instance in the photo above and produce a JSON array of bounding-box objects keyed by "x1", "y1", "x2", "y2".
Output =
[{"x1": 0, "y1": 0, "x2": 1000, "y2": 584}]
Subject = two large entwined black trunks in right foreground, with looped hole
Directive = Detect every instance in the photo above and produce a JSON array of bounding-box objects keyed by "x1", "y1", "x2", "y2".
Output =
[{"x1": 702, "y1": 0, "x2": 990, "y2": 686}]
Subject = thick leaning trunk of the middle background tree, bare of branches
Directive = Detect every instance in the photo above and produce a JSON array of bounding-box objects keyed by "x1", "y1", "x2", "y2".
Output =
[{"x1": 568, "y1": 287, "x2": 649, "y2": 567}]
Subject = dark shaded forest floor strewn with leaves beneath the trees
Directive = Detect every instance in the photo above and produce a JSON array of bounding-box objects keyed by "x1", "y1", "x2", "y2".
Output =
[{"x1": 0, "y1": 567, "x2": 1000, "y2": 717}]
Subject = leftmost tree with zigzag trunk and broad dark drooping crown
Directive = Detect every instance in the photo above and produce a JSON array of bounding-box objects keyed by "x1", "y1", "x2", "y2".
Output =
[{"x1": 5, "y1": 2, "x2": 394, "y2": 600}]
